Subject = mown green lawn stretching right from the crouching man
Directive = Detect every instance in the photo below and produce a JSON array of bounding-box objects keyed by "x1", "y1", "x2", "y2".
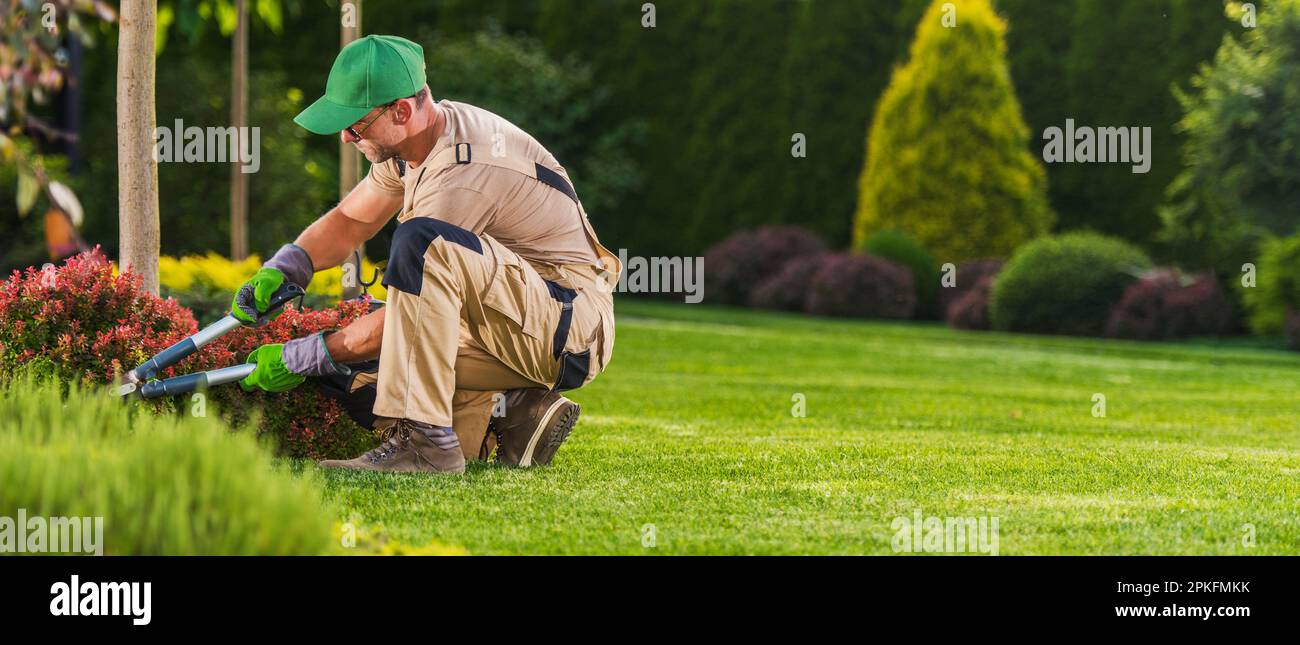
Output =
[{"x1": 317, "y1": 299, "x2": 1300, "y2": 554}]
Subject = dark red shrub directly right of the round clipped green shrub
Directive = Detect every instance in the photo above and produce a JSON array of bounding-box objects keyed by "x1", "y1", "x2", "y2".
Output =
[{"x1": 1106, "y1": 269, "x2": 1232, "y2": 341}]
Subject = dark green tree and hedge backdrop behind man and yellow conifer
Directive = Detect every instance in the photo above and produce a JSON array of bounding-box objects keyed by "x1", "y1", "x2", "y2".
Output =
[{"x1": 0, "y1": 0, "x2": 1266, "y2": 267}]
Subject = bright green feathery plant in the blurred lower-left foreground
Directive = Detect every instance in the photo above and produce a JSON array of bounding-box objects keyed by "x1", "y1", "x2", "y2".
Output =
[{"x1": 0, "y1": 373, "x2": 333, "y2": 555}]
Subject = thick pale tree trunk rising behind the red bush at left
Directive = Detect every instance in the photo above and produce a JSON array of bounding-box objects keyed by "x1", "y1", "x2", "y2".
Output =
[{"x1": 117, "y1": 0, "x2": 159, "y2": 294}]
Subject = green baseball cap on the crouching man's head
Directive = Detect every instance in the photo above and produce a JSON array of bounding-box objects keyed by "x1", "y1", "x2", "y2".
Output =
[{"x1": 294, "y1": 35, "x2": 425, "y2": 134}]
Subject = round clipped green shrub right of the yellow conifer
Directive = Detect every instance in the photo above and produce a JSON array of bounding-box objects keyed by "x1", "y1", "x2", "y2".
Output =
[{"x1": 989, "y1": 233, "x2": 1151, "y2": 336}]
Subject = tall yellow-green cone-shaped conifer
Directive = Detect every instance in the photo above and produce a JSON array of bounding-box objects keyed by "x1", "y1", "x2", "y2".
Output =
[{"x1": 854, "y1": 0, "x2": 1053, "y2": 263}]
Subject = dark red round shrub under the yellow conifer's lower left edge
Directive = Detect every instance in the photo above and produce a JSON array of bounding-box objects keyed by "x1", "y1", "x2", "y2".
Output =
[{"x1": 805, "y1": 254, "x2": 917, "y2": 320}]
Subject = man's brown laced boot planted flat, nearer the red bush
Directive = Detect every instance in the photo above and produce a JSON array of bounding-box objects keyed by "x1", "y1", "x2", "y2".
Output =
[{"x1": 317, "y1": 419, "x2": 465, "y2": 473}]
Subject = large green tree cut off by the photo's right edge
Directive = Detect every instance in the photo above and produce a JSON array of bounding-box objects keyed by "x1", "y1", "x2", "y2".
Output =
[{"x1": 1160, "y1": 0, "x2": 1300, "y2": 274}]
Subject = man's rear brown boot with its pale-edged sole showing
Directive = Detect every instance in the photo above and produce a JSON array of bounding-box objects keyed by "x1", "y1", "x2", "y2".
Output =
[{"x1": 488, "y1": 388, "x2": 580, "y2": 467}]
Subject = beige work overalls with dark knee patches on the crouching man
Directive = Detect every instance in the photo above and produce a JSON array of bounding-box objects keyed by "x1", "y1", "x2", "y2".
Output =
[{"x1": 364, "y1": 142, "x2": 623, "y2": 459}]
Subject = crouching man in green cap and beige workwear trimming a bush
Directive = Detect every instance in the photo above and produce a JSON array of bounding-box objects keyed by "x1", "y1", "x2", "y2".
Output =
[{"x1": 231, "y1": 35, "x2": 621, "y2": 473}]
